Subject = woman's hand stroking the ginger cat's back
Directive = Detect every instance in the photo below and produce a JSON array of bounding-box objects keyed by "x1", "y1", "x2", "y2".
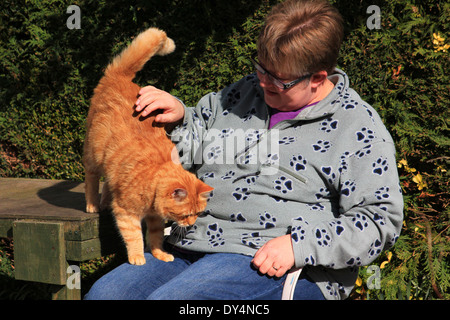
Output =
[{"x1": 136, "y1": 86, "x2": 184, "y2": 123}]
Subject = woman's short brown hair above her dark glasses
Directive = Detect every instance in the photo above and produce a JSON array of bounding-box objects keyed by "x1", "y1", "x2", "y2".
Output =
[{"x1": 257, "y1": 0, "x2": 343, "y2": 78}]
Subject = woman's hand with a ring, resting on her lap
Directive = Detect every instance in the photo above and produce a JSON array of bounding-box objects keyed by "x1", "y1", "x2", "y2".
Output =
[{"x1": 252, "y1": 234, "x2": 295, "y2": 278}]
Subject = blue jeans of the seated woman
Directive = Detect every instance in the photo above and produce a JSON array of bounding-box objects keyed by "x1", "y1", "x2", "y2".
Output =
[{"x1": 85, "y1": 249, "x2": 324, "y2": 300}]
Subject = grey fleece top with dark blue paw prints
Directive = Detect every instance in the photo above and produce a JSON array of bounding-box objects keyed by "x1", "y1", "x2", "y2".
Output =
[{"x1": 168, "y1": 70, "x2": 403, "y2": 299}]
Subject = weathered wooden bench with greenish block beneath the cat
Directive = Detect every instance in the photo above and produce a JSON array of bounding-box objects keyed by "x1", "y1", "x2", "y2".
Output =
[{"x1": 0, "y1": 178, "x2": 124, "y2": 300}]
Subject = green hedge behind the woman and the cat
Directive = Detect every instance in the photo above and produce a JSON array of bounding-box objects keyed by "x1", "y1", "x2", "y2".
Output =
[{"x1": 0, "y1": 0, "x2": 450, "y2": 299}]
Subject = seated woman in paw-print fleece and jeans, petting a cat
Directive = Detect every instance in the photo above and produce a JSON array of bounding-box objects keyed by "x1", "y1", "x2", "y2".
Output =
[{"x1": 86, "y1": 0, "x2": 403, "y2": 299}]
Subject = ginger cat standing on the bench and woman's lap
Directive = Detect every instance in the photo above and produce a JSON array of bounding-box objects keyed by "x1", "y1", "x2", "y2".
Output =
[{"x1": 83, "y1": 28, "x2": 213, "y2": 265}]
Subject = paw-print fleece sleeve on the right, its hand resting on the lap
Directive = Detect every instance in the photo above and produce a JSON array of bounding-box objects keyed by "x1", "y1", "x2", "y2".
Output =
[{"x1": 291, "y1": 141, "x2": 403, "y2": 269}]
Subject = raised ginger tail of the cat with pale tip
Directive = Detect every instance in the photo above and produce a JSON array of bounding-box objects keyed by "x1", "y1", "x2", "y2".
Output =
[{"x1": 105, "y1": 28, "x2": 175, "y2": 81}]
